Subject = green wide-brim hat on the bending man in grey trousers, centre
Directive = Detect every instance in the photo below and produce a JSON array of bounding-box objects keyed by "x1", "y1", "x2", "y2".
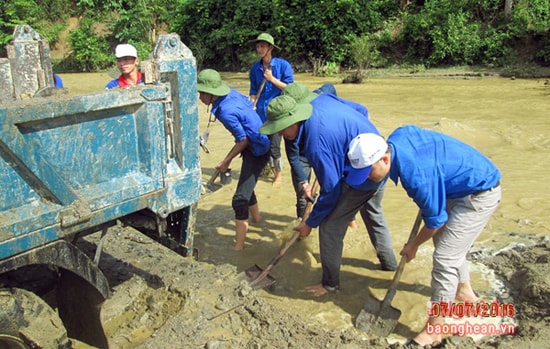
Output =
[{"x1": 260, "y1": 96, "x2": 313, "y2": 135}]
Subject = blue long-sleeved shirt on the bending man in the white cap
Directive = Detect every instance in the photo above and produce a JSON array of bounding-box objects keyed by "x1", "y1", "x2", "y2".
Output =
[{"x1": 388, "y1": 125, "x2": 501, "y2": 229}]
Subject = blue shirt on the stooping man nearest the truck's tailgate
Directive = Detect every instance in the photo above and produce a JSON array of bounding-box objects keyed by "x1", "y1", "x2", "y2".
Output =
[{"x1": 212, "y1": 89, "x2": 270, "y2": 156}]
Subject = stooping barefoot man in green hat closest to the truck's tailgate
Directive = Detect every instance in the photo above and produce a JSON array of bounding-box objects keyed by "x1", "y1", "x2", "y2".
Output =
[{"x1": 197, "y1": 69, "x2": 270, "y2": 251}]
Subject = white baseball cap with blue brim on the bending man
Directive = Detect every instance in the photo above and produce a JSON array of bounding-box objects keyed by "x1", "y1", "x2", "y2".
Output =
[{"x1": 346, "y1": 133, "x2": 388, "y2": 186}]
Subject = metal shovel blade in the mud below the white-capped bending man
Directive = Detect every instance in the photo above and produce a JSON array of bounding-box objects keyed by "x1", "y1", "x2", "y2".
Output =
[{"x1": 355, "y1": 297, "x2": 401, "y2": 337}]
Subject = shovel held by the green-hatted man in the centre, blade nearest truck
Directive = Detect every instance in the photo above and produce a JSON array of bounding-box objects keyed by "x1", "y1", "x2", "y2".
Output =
[{"x1": 240, "y1": 178, "x2": 318, "y2": 289}]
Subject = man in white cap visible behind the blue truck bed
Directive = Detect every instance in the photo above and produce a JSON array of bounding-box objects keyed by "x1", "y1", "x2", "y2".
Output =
[{"x1": 105, "y1": 44, "x2": 142, "y2": 90}]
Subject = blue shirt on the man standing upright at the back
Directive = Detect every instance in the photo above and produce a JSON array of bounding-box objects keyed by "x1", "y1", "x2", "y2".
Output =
[{"x1": 249, "y1": 57, "x2": 294, "y2": 123}]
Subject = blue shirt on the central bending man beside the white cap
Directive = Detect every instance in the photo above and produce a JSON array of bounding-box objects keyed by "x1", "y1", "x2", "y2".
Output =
[{"x1": 297, "y1": 94, "x2": 379, "y2": 228}]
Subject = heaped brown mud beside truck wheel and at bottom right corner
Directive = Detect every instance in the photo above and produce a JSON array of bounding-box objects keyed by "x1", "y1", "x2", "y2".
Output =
[{"x1": 78, "y1": 223, "x2": 550, "y2": 349}]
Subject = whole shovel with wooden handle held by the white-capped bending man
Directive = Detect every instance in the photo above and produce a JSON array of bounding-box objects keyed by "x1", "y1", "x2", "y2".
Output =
[{"x1": 355, "y1": 210, "x2": 422, "y2": 337}]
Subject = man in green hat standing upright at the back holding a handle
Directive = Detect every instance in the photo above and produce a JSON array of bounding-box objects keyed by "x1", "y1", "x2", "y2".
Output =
[{"x1": 249, "y1": 33, "x2": 294, "y2": 184}]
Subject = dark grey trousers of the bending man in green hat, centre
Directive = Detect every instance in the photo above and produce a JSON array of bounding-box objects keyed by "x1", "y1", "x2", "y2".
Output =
[{"x1": 319, "y1": 183, "x2": 397, "y2": 288}]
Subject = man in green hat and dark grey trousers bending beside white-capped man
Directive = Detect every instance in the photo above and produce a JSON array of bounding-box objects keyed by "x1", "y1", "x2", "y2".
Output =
[{"x1": 260, "y1": 94, "x2": 397, "y2": 296}]
